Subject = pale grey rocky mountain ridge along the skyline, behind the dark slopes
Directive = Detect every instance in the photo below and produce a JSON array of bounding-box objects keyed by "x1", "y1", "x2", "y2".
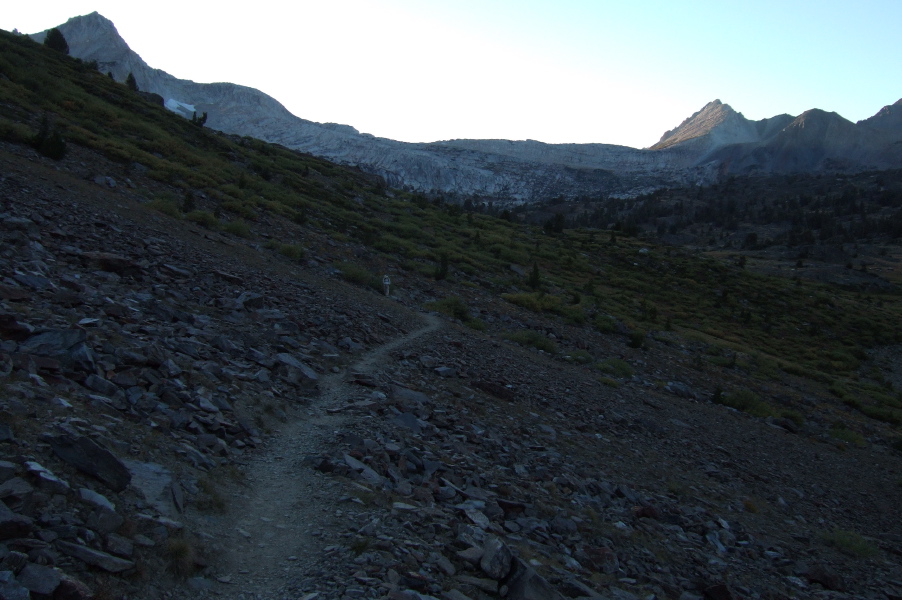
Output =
[{"x1": 33, "y1": 12, "x2": 902, "y2": 202}]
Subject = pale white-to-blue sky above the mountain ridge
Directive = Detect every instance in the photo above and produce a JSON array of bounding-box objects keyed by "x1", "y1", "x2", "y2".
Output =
[{"x1": 0, "y1": 0, "x2": 902, "y2": 148}]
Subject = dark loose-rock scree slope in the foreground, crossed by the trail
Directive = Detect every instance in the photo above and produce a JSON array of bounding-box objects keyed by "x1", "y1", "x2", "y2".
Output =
[{"x1": 0, "y1": 135, "x2": 902, "y2": 600}]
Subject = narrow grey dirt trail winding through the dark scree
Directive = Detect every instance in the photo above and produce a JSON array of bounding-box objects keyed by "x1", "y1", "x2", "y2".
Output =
[{"x1": 201, "y1": 315, "x2": 442, "y2": 600}]
